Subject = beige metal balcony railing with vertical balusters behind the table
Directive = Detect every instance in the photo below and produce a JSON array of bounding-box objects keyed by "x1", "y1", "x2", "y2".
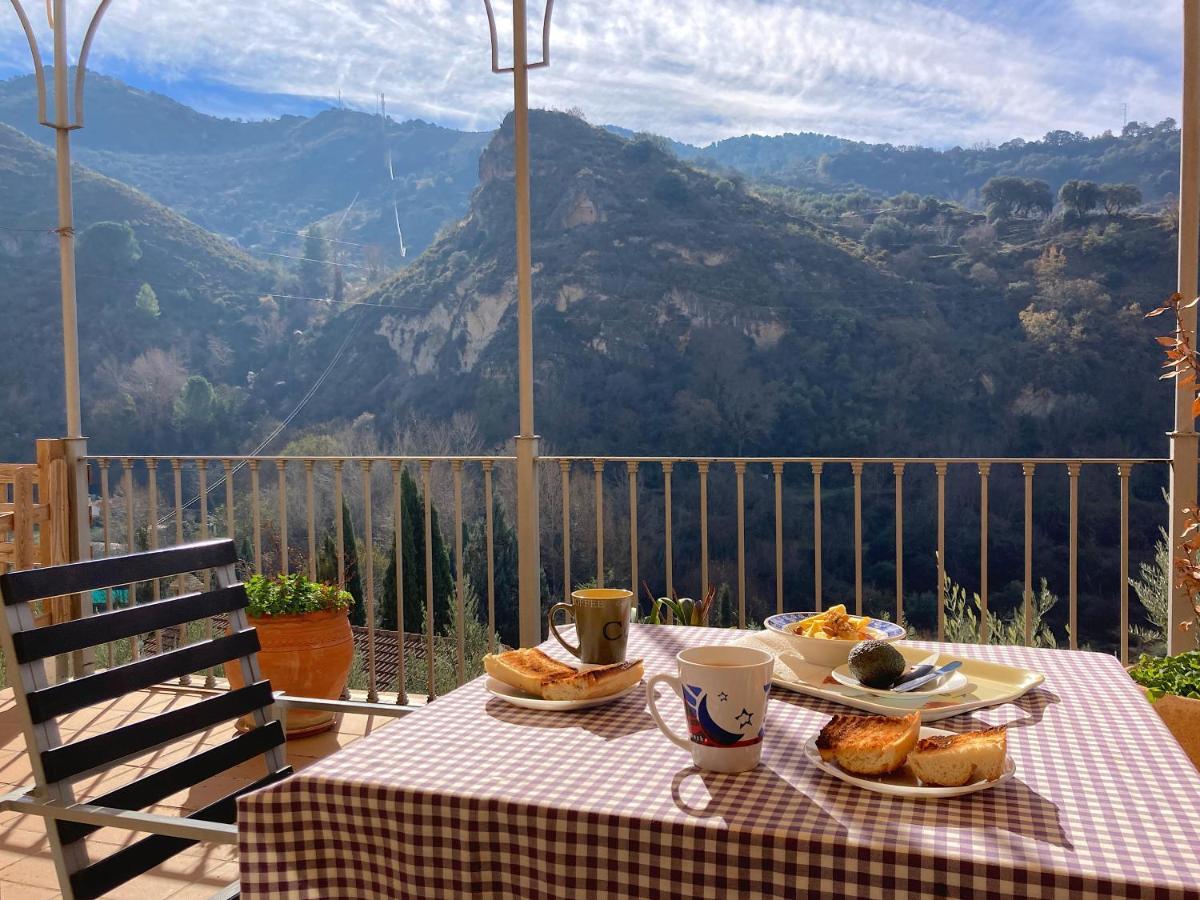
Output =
[{"x1": 77, "y1": 456, "x2": 1166, "y2": 704}]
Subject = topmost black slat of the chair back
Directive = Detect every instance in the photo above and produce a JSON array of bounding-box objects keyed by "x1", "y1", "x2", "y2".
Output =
[{"x1": 0, "y1": 538, "x2": 238, "y2": 606}]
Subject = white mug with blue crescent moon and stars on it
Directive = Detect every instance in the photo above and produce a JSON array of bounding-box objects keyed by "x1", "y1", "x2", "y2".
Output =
[{"x1": 646, "y1": 646, "x2": 775, "y2": 772}]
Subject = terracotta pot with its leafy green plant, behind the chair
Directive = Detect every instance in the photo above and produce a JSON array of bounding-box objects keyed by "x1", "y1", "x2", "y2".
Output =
[{"x1": 227, "y1": 572, "x2": 354, "y2": 738}]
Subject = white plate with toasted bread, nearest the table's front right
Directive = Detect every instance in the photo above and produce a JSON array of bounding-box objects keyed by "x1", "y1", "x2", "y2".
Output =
[{"x1": 804, "y1": 712, "x2": 1016, "y2": 799}]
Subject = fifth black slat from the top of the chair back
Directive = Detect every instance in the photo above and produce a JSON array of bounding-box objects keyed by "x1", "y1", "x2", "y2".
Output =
[{"x1": 59, "y1": 719, "x2": 287, "y2": 844}]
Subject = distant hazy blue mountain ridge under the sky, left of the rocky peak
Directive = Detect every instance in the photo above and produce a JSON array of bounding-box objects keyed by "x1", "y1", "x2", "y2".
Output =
[{"x1": 0, "y1": 72, "x2": 488, "y2": 264}]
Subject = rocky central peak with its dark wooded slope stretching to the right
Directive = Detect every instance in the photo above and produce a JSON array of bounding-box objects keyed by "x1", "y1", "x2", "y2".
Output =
[{"x1": 250, "y1": 112, "x2": 1172, "y2": 465}]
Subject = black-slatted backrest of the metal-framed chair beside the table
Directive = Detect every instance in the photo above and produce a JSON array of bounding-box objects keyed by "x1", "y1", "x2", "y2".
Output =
[{"x1": 0, "y1": 540, "x2": 292, "y2": 898}]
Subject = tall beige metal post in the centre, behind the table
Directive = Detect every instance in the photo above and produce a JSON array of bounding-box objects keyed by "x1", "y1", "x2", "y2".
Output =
[{"x1": 484, "y1": 0, "x2": 554, "y2": 647}]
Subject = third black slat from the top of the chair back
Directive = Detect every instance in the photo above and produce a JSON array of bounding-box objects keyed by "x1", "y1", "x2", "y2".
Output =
[{"x1": 25, "y1": 629, "x2": 259, "y2": 724}]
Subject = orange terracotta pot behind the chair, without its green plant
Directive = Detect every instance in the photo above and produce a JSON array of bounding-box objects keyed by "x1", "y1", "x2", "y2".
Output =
[{"x1": 226, "y1": 610, "x2": 354, "y2": 738}]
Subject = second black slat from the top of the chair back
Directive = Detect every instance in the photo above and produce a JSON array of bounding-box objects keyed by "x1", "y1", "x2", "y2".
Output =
[{"x1": 12, "y1": 584, "x2": 247, "y2": 662}]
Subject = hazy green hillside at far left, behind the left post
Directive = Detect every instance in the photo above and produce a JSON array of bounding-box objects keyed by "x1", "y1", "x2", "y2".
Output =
[{"x1": 0, "y1": 125, "x2": 281, "y2": 458}]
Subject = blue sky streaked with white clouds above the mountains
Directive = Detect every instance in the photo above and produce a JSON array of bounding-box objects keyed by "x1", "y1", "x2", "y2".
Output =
[{"x1": 0, "y1": 0, "x2": 1181, "y2": 146}]
